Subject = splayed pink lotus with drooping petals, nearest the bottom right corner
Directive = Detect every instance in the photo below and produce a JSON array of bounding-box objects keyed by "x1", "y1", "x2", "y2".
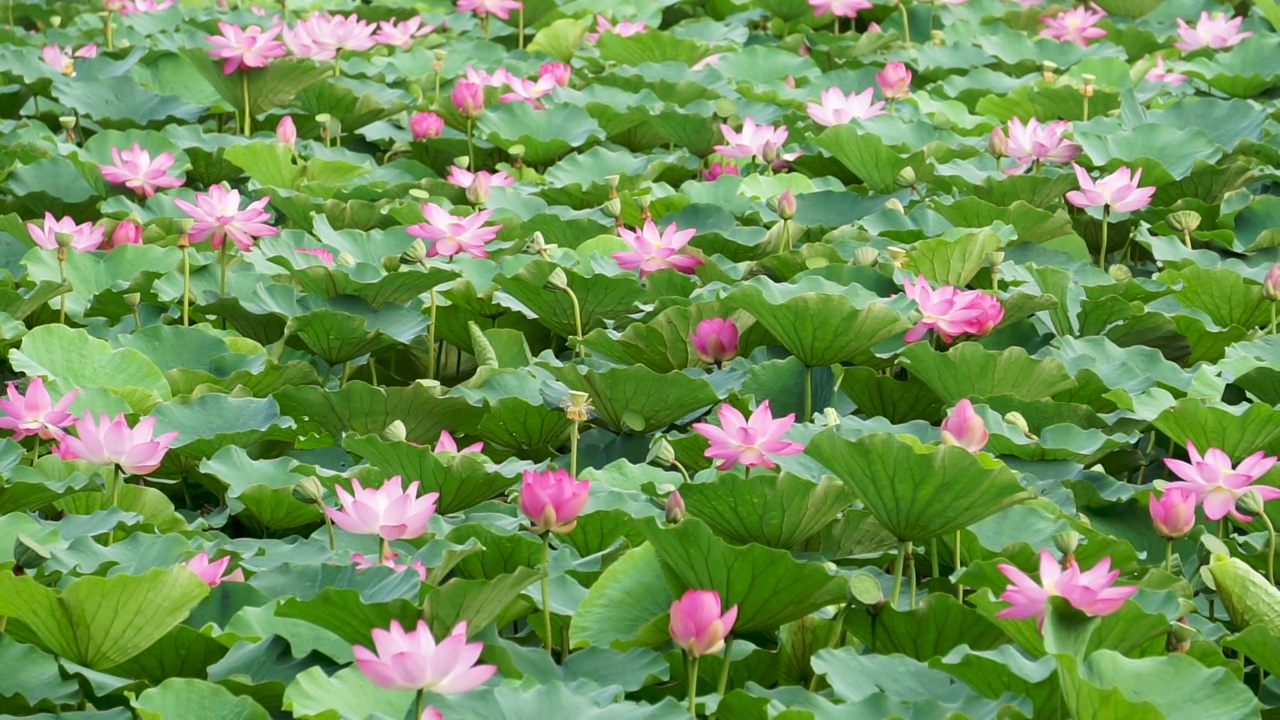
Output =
[{"x1": 996, "y1": 548, "x2": 1138, "y2": 626}]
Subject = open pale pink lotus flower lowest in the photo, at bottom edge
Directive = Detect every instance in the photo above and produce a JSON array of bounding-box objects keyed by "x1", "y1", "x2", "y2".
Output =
[{"x1": 351, "y1": 620, "x2": 498, "y2": 694}]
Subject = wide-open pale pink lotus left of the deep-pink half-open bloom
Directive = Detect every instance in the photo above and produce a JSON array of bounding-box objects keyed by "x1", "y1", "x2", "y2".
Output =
[{"x1": 324, "y1": 475, "x2": 440, "y2": 541}]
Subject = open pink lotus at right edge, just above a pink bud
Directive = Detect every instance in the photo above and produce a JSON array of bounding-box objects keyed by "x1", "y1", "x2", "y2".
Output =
[{"x1": 1165, "y1": 442, "x2": 1280, "y2": 523}]
